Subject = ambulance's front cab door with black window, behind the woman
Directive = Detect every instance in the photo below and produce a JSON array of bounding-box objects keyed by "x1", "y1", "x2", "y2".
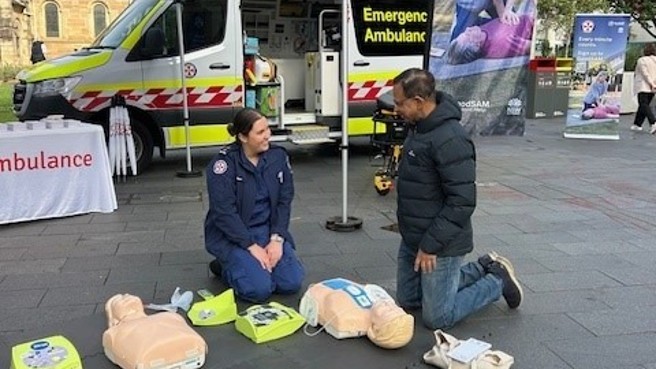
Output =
[{"x1": 128, "y1": 0, "x2": 243, "y2": 148}]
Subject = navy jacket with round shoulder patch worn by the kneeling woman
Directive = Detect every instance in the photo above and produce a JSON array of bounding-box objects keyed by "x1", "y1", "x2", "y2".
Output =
[{"x1": 205, "y1": 144, "x2": 294, "y2": 260}]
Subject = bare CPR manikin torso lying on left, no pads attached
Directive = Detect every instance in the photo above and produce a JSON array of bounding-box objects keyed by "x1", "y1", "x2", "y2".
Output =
[{"x1": 103, "y1": 295, "x2": 207, "y2": 369}]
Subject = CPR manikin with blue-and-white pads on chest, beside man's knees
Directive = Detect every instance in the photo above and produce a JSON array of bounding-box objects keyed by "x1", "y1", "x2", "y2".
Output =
[{"x1": 299, "y1": 278, "x2": 415, "y2": 349}]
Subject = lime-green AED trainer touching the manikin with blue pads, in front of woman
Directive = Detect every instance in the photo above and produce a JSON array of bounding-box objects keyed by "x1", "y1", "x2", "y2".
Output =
[{"x1": 235, "y1": 302, "x2": 305, "y2": 343}]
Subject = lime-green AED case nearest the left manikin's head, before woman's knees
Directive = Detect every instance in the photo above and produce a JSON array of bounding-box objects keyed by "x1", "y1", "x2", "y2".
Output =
[{"x1": 187, "y1": 288, "x2": 237, "y2": 326}]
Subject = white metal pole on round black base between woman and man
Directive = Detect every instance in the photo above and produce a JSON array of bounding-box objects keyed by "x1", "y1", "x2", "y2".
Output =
[{"x1": 319, "y1": 0, "x2": 362, "y2": 232}]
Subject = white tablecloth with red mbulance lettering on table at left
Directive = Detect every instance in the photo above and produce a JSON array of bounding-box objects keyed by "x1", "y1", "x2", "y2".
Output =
[{"x1": 0, "y1": 122, "x2": 118, "y2": 224}]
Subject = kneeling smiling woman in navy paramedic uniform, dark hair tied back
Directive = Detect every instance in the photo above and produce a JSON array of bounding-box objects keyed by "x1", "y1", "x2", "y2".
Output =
[{"x1": 205, "y1": 108, "x2": 305, "y2": 302}]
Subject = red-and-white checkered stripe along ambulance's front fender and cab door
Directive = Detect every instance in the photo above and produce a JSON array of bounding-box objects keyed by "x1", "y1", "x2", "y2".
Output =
[{"x1": 69, "y1": 85, "x2": 243, "y2": 111}]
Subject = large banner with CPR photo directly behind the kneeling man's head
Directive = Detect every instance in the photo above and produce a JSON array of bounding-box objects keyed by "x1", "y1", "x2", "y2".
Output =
[{"x1": 424, "y1": 0, "x2": 537, "y2": 136}]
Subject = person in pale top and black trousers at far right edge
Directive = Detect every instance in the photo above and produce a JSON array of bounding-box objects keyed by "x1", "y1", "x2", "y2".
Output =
[{"x1": 631, "y1": 43, "x2": 656, "y2": 134}]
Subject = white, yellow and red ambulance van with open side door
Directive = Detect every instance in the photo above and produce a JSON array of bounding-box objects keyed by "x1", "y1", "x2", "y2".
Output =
[{"x1": 13, "y1": 0, "x2": 430, "y2": 172}]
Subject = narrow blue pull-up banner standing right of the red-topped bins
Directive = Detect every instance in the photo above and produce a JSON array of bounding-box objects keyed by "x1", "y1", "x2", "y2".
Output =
[{"x1": 563, "y1": 14, "x2": 630, "y2": 140}]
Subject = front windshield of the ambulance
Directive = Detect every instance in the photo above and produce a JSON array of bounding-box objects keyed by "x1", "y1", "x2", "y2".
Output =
[{"x1": 90, "y1": 0, "x2": 161, "y2": 49}]
